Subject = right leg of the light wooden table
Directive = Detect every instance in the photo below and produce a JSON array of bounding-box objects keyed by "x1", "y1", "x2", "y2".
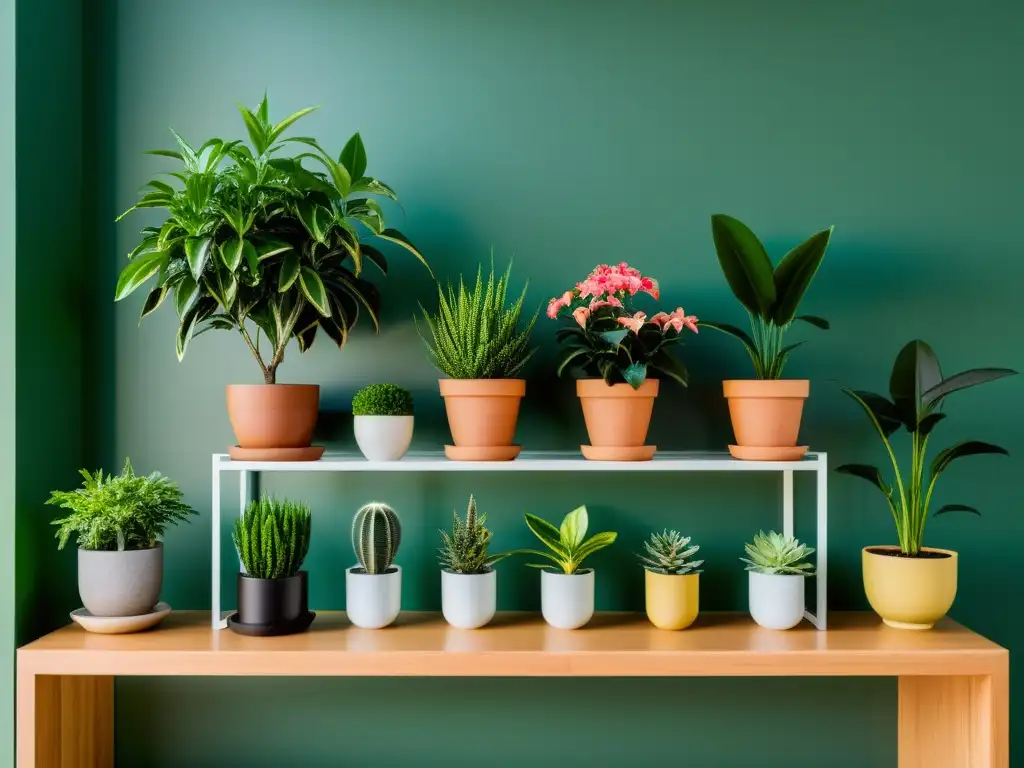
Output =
[{"x1": 899, "y1": 665, "x2": 1010, "y2": 768}]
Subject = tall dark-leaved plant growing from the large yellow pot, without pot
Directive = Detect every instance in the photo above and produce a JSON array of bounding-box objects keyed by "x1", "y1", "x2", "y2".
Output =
[{"x1": 836, "y1": 339, "x2": 1017, "y2": 556}]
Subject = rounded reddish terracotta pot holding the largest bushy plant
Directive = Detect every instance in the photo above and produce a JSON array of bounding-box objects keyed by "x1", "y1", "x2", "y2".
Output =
[{"x1": 227, "y1": 384, "x2": 319, "y2": 449}]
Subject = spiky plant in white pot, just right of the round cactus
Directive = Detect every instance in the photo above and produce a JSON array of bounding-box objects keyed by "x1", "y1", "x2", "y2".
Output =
[{"x1": 437, "y1": 496, "x2": 512, "y2": 630}]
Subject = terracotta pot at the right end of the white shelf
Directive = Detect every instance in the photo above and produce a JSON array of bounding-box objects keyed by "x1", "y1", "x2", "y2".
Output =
[{"x1": 722, "y1": 379, "x2": 811, "y2": 447}]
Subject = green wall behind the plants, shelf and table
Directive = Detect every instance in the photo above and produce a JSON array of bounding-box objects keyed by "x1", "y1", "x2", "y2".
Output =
[{"x1": 66, "y1": 0, "x2": 1024, "y2": 766}]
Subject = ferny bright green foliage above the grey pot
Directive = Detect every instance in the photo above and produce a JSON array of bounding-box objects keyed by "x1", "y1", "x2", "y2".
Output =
[{"x1": 46, "y1": 459, "x2": 196, "y2": 551}]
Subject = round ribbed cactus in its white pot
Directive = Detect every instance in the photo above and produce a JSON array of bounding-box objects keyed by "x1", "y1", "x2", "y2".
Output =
[{"x1": 345, "y1": 502, "x2": 401, "y2": 630}]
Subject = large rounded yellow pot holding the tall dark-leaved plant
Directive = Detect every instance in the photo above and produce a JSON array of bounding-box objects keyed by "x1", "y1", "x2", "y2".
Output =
[{"x1": 861, "y1": 547, "x2": 957, "y2": 630}]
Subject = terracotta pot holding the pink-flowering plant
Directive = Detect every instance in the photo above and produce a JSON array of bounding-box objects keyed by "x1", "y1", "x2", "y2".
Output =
[{"x1": 577, "y1": 379, "x2": 658, "y2": 461}]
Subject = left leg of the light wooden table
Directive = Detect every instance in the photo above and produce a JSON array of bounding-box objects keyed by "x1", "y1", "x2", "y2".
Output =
[{"x1": 17, "y1": 668, "x2": 114, "y2": 768}]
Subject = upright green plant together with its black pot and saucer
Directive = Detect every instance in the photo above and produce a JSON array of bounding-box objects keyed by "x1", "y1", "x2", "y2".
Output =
[{"x1": 227, "y1": 496, "x2": 315, "y2": 637}]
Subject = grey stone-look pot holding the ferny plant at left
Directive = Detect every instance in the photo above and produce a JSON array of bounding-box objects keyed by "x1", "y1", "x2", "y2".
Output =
[{"x1": 78, "y1": 542, "x2": 164, "y2": 616}]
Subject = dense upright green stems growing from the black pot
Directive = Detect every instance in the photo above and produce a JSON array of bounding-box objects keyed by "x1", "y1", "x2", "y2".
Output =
[{"x1": 231, "y1": 496, "x2": 312, "y2": 579}]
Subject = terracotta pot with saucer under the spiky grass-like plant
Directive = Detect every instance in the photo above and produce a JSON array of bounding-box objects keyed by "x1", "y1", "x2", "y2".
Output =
[{"x1": 440, "y1": 379, "x2": 526, "y2": 461}]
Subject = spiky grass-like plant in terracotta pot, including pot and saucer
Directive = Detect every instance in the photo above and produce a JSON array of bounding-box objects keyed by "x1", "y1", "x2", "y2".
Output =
[{"x1": 420, "y1": 260, "x2": 537, "y2": 461}]
